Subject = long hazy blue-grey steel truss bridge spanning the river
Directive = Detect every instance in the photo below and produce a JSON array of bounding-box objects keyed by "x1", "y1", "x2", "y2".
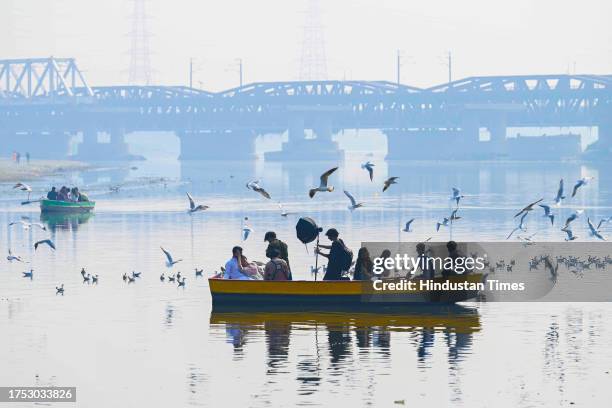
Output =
[{"x1": 0, "y1": 57, "x2": 612, "y2": 159}]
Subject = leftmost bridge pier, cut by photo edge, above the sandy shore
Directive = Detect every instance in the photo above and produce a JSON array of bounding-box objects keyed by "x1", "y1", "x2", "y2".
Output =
[{"x1": 0, "y1": 131, "x2": 71, "y2": 160}]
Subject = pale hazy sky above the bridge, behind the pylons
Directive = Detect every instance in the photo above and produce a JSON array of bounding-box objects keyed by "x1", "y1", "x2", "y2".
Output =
[{"x1": 0, "y1": 0, "x2": 612, "y2": 90}]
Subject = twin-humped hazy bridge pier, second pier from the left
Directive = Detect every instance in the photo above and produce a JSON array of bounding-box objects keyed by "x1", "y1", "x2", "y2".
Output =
[{"x1": 74, "y1": 129, "x2": 136, "y2": 161}]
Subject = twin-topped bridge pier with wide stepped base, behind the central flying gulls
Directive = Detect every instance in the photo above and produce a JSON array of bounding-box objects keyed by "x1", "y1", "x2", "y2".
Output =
[{"x1": 265, "y1": 116, "x2": 344, "y2": 161}]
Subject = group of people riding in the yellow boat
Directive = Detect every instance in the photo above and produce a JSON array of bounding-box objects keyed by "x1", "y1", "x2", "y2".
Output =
[{"x1": 218, "y1": 228, "x2": 462, "y2": 281}]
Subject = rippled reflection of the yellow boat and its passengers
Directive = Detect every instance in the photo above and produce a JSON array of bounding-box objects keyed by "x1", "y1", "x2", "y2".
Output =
[{"x1": 210, "y1": 305, "x2": 481, "y2": 395}]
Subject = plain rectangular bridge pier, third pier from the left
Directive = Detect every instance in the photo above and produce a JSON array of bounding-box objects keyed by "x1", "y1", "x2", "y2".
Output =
[{"x1": 177, "y1": 130, "x2": 257, "y2": 161}]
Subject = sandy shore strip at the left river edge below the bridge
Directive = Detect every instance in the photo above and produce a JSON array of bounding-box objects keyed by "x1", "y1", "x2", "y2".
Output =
[{"x1": 0, "y1": 159, "x2": 90, "y2": 182}]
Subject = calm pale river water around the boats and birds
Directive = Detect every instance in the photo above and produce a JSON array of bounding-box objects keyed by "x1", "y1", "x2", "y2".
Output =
[{"x1": 0, "y1": 157, "x2": 612, "y2": 408}]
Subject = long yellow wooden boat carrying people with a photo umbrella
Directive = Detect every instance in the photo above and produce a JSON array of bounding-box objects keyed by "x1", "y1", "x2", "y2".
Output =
[{"x1": 209, "y1": 273, "x2": 485, "y2": 307}]
